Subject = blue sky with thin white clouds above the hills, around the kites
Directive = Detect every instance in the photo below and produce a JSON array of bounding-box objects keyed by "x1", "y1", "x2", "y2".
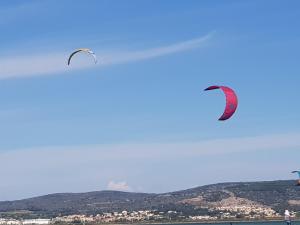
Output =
[{"x1": 0, "y1": 0, "x2": 300, "y2": 200}]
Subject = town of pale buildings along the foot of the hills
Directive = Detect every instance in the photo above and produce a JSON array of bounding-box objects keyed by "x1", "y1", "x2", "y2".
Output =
[{"x1": 0, "y1": 206, "x2": 296, "y2": 225}]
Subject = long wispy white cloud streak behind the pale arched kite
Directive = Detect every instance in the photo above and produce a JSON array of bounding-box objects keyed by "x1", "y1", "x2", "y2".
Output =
[{"x1": 0, "y1": 33, "x2": 213, "y2": 79}]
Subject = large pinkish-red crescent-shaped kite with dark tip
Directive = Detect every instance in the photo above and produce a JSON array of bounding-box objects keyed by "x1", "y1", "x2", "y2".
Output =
[{"x1": 204, "y1": 86, "x2": 238, "y2": 121}]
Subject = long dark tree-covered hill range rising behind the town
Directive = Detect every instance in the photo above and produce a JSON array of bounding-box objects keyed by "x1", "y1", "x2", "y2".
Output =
[{"x1": 0, "y1": 180, "x2": 300, "y2": 216}]
